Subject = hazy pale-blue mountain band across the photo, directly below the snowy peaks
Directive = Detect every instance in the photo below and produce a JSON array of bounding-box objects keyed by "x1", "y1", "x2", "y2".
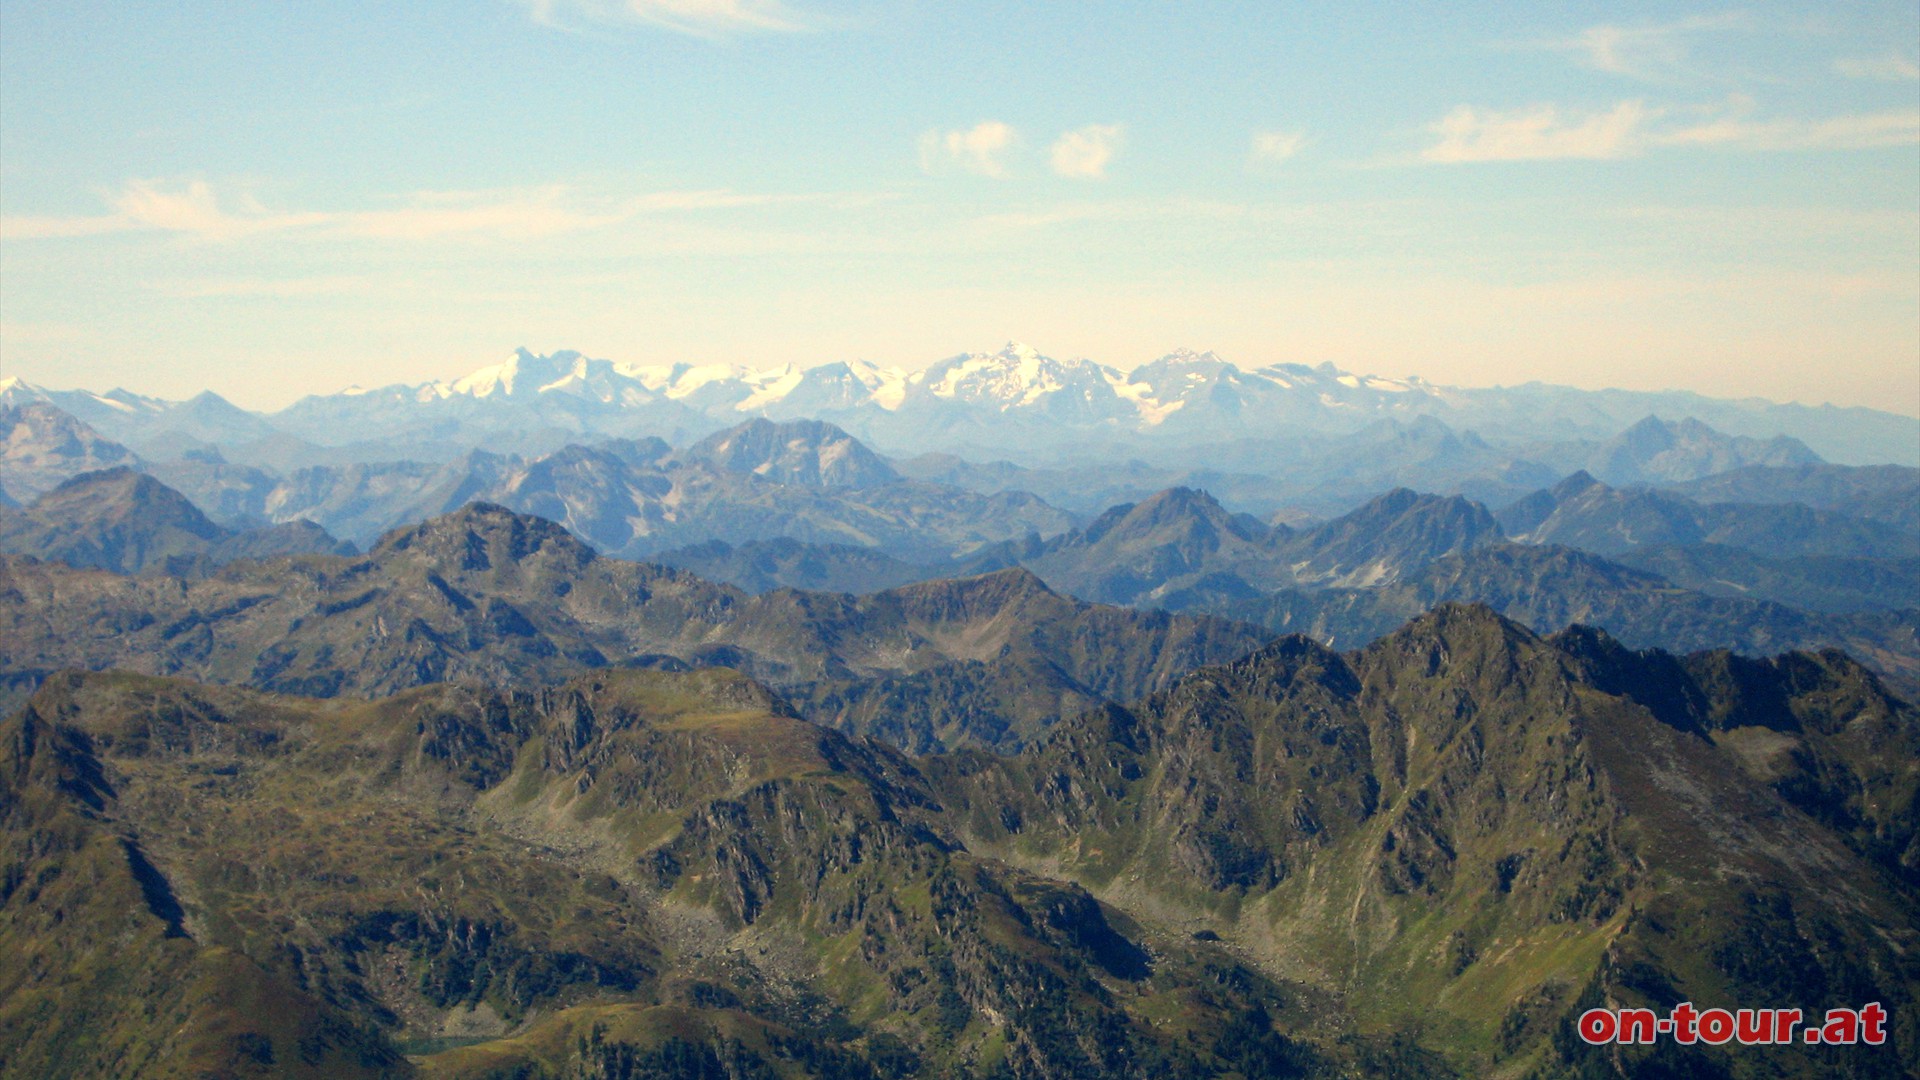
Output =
[{"x1": 0, "y1": 395, "x2": 1920, "y2": 549}]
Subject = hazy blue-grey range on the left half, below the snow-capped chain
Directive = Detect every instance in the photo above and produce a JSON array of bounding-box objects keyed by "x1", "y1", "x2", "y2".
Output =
[{"x1": 0, "y1": 404, "x2": 1073, "y2": 563}]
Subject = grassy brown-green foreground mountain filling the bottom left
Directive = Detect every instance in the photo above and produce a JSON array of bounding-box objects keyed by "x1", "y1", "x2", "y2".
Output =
[{"x1": 0, "y1": 671, "x2": 1342, "y2": 1076}]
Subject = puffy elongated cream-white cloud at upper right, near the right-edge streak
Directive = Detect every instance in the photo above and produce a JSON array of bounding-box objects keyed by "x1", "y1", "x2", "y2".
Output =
[{"x1": 1421, "y1": 102, "x2": 1659, "y2": 163}]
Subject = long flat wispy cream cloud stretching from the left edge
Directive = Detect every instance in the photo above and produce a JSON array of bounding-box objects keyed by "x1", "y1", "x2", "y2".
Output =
[{"x1": 0, "y1": 181, "x2": 795, "y2": 242}]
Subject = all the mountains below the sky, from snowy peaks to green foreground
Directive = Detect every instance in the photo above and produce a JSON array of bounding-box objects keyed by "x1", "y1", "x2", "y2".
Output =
[{"x1": 0, "y1": 346, "x2": 1920, "y2": 1080}]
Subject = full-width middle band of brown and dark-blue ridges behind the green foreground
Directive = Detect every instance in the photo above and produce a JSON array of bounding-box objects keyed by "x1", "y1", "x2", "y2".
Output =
[{"x1": 11, "y1": 488, "x2": 1920, "y2": 737}]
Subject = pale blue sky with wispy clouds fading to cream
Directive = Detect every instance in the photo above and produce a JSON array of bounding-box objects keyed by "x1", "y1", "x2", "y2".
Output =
[{"x1": 0, "y1": 0, "x2": 1920, "y2": 415}]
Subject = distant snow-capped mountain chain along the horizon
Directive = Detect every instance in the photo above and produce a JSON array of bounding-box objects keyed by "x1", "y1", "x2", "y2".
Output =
[{"x1": 0, "y1": 342, "x2": 1920, "y2": 463}]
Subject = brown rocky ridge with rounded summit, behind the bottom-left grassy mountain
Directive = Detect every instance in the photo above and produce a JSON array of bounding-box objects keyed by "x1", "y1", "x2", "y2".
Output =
[{"x1": 0, "y1": 503, "x2": 1267, "y2": 749}]
